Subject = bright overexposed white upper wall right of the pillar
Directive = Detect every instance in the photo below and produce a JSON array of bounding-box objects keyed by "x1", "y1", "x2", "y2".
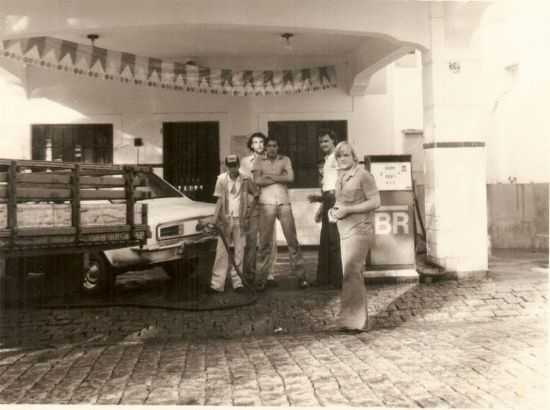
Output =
[{"x1": 480, "y1": 1, "x2": 550, "y2": 183}]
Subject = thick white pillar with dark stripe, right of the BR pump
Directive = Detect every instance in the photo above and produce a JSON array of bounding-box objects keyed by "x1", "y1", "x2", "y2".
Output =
[{"x1": 423, "y1": 3, "x2": 488, "y2": 279}]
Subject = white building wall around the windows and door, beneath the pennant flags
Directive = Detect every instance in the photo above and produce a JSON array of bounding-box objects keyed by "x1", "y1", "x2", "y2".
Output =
[{"x1": 0, "y1": 59, "x2": 400, "y2": 243}]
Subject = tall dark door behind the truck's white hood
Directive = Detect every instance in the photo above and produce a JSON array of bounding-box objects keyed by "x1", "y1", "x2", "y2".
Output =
[{"x1": 162, "y1": 122, "x2": 220, "y2": 202}]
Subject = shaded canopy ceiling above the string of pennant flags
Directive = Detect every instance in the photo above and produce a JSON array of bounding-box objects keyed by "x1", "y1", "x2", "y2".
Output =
[{"x1": 50, "y1": 26, "x2": 384, "y2": 60}]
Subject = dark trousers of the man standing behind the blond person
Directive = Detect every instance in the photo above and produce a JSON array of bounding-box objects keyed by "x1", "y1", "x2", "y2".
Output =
[{"x1": 317, "y1": 192, "x2": 343, "y2": 289}]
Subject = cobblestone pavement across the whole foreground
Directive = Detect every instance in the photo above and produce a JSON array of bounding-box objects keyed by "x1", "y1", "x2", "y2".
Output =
[{"x1": 0, "y1": 253, "x2": 550, "y2": 409}]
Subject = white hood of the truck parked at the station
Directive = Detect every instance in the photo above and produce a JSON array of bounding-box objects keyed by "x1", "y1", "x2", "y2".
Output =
[{"x1": 138, "y1": 197, "x2": 216, "y2": 228}]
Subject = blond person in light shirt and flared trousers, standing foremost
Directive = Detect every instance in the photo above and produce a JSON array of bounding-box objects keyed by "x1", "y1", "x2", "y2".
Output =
[{"x1": 330, "y1": 141, "x2": 380, "y2": 333}]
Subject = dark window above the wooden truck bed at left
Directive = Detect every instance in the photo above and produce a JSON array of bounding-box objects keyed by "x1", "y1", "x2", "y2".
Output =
[{"x1": 32, "y1": 124, "x2": 113, "y2": 164}]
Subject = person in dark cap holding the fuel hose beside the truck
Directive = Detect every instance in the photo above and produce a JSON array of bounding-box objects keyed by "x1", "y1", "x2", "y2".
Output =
[{"x1": 209, "y1": 155, "x2": 257, "y2": 293}]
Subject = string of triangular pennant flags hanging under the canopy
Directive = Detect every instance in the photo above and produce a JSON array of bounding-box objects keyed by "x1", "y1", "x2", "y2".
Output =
[{"x1": 0, "y1": 37, "x2": 336, "y2": 96}]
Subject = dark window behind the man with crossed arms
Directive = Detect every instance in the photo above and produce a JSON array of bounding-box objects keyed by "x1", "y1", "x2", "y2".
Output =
[{"x1": 268, "y1": 120, "x2": 348, "y2": 188}]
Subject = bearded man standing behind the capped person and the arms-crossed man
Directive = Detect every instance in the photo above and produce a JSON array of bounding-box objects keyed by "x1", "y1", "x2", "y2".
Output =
[{"x1": 240, "y1": 132, "x2": 277, "y2": 287}]
